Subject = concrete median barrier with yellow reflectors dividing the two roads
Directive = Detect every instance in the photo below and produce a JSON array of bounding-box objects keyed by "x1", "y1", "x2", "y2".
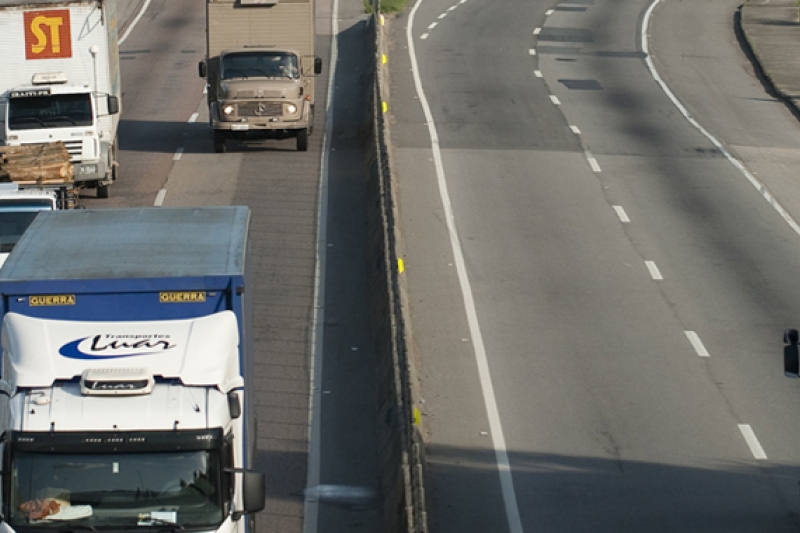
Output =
[{"x1": 365, "y1": 10, "x2": 427, "y2": 533}]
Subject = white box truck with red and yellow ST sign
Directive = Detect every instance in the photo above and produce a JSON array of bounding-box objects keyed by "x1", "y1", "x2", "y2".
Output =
[{"x1": 0, "y1": 0, "x2": 121, "y2": 198}]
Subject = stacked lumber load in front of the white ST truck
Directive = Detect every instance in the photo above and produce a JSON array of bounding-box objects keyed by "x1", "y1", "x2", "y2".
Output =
[{"x1": 0, "y1": 141, "x2": 73, "y2": 186}]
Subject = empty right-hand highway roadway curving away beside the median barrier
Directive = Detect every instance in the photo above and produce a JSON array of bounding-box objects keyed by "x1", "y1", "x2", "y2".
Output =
[{"x1": 390, "y1": 0, "x2": 800, "y2": 533}]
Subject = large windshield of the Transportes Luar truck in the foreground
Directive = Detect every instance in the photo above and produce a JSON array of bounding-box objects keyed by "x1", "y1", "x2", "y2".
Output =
[{"x1": 6, "y1": 450, "x2": 224, "y2": 530}]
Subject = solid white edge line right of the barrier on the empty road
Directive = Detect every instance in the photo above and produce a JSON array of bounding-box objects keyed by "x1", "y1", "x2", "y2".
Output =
[{"x1": 406, "y1": 0, "x2": 523, "y2": 533}]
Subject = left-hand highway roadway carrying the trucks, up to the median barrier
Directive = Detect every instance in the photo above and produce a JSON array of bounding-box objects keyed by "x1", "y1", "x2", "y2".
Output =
[{"x1": 94, "y1": 0, "x2": 380, "y2": 533}]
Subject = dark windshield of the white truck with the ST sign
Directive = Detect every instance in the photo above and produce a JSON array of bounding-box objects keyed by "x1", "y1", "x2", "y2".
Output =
[{"x1": 8, "y1": 94, "x2": 92, "y2": 130}]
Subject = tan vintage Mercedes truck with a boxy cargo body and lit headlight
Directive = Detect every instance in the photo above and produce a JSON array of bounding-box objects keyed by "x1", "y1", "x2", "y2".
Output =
[{"x1": 199, "y1": 0, "x2": 322, "y2": 153}]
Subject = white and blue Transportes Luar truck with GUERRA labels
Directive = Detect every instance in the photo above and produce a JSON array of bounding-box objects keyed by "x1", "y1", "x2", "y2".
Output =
[{"x1": 0, "y1": 207, "x2": 265, "y2": 533}]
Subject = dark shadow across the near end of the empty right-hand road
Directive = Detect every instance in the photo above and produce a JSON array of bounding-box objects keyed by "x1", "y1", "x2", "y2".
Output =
[{"x1": 425, "y1": 443, "x2": 800, "y2": 533}]
